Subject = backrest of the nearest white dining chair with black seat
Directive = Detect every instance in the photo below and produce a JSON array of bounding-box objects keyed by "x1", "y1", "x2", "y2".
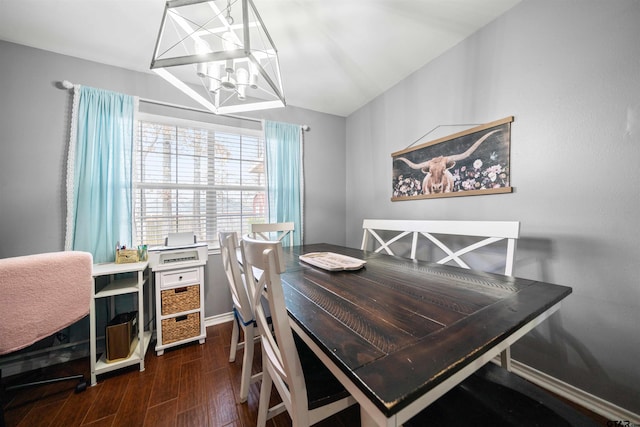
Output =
[{"x1": 241, "y1": 236, "x2": 308, "y2": 425}]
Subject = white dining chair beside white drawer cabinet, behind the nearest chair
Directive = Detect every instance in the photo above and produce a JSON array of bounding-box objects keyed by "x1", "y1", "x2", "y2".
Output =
[{"x1": 218, "y1": 232, "x2": 262, "y2": 403}]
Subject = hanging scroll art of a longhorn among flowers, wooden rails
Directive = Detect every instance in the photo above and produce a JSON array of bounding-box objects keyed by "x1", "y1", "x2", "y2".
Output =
[{"x1": 391, "y1": 116, "x2": 513, "y2": 202}]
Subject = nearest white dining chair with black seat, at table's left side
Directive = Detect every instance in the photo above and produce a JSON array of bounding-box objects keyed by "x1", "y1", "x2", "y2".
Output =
[{"x1": 241, "y1": 236, "x2": 355, "y2": 427}]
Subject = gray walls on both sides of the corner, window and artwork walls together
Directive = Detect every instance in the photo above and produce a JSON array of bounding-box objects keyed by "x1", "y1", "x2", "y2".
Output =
[{"x1": 0, "y1": 0, "x2": 640, "y2": 413}]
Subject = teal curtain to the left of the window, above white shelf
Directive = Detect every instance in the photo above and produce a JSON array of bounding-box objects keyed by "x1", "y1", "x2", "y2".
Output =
[{"x1": 65, "y1": 86, "x2": 137, "y2": 263}]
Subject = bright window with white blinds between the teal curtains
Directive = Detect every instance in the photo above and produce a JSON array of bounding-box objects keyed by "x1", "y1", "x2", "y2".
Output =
[{"x1": 134, "y1": 114, "x2": 267, "y2": 247}]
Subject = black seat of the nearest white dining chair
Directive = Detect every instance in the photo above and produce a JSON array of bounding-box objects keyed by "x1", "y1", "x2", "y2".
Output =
[{"x1": 293, "y1": 333, "x2": 349, "y2": 410}]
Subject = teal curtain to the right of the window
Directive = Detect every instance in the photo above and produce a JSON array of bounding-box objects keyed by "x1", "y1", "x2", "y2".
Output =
[{"x1": 264, "y1": 121, "x2": 304, "y2": 245}]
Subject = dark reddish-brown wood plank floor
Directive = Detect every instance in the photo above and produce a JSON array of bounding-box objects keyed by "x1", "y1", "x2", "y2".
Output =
[{"x1": 3, "y1": 322, "x2": 607, "y2": 427}]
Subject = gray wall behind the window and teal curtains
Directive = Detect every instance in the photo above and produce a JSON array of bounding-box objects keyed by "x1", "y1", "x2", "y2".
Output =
[{"x1": 0, "y1": 41, "x2": 346, "y2": 332}]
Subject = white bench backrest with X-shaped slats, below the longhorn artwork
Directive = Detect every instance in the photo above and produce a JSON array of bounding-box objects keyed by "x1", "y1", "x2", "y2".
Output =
[{"x1": 361, "y1": 219, "x2": 520, "y2": 276}]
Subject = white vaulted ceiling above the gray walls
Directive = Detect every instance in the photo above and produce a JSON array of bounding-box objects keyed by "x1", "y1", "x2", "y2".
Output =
[{"x1": 0, "y1": 0, "x2": 520, "y2": 116}]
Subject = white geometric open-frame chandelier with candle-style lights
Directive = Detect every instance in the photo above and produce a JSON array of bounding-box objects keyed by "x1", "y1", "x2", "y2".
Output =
[{"x1": 151, "y1": 0, "x2": 286, "y2": 114}]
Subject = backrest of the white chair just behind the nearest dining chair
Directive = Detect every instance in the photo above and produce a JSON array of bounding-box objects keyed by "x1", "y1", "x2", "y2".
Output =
[{"x1": 218, "y1": 232, "x2": 255, "y2": 324}]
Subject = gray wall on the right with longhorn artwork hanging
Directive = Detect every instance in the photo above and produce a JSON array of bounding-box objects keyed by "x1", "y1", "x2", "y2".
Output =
[{"x1": 346, "y1": 0, "x2": 640, "y2": 413}]
